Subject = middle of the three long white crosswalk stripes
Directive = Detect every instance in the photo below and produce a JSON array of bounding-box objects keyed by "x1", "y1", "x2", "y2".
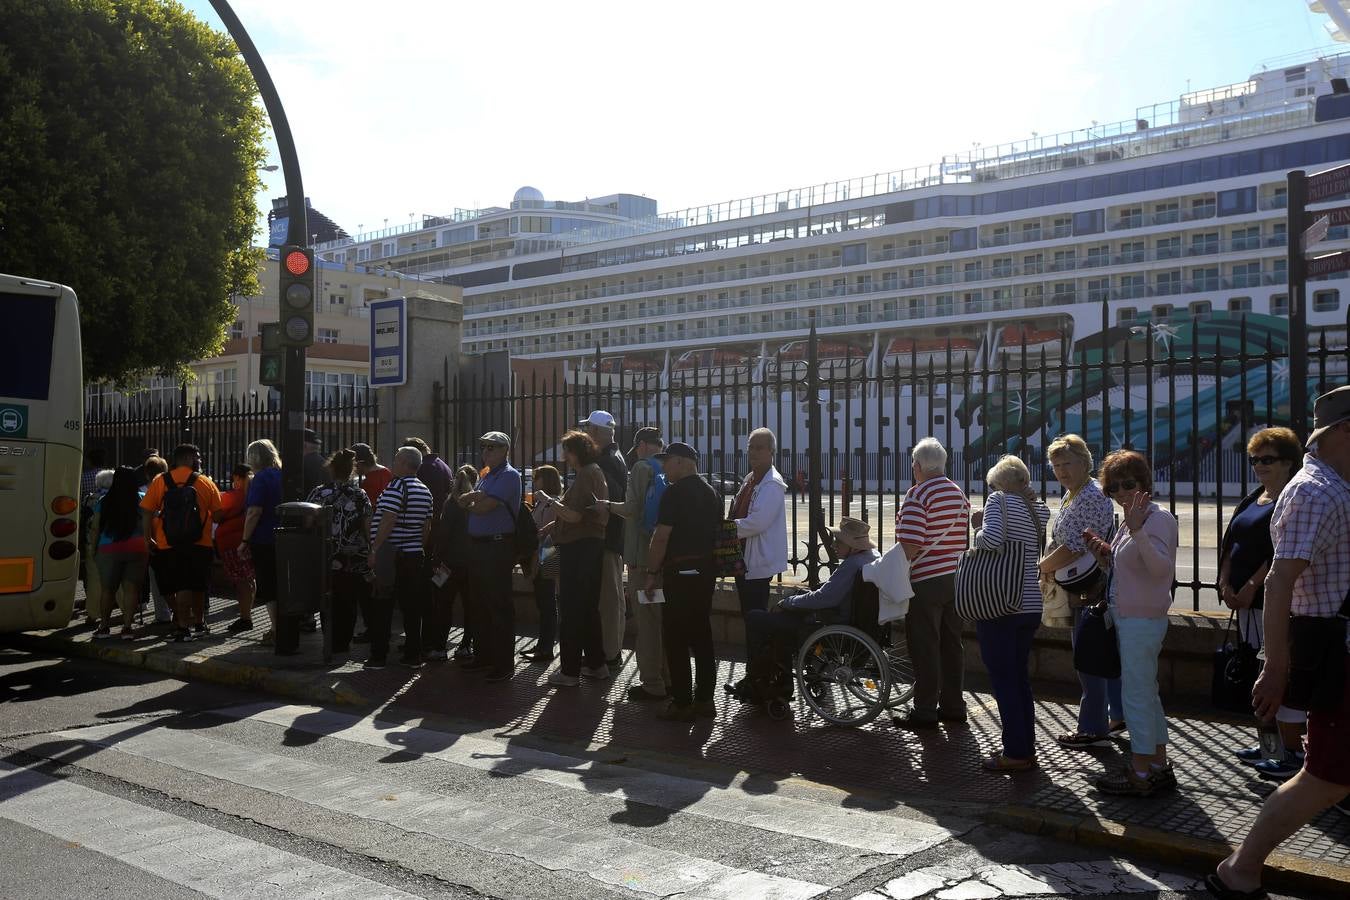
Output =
[{"x1": 54, "y1": 725, "x2": 826, "y2": 900}]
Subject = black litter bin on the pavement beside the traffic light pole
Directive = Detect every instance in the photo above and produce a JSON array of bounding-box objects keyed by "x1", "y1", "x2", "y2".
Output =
[{"x1": 275, "y1": 502, "x2": 329, "y2": 658}]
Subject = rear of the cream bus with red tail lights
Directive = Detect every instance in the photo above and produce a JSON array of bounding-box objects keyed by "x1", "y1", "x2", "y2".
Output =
[{"x1": 0, "y1": 275, "x2": 84, "y2": 633}]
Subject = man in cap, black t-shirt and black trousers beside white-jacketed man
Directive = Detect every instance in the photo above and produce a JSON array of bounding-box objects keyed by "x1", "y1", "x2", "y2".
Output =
[{"x1": 645, "y1": 443, "x2": 722, "y2": 722}]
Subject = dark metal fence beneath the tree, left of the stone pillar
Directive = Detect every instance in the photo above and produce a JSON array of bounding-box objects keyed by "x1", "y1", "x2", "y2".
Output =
[{"x1": 84, "y1": 385, "x2": 379, "y2": 487}]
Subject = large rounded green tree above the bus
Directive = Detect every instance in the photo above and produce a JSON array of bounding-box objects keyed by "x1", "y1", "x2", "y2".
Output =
[{"x1": 0, "y1": 0, "x2": 265, "y2": 382}]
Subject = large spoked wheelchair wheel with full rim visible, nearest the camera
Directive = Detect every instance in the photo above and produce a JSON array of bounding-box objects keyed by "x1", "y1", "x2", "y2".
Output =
[{"x1": 797, "y1": 625, "x2": 891, "y2": 727}]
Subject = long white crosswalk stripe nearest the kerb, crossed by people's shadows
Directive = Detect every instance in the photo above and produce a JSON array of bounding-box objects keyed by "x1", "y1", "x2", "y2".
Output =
[{"x1": 212, "y1": 703, "x2": 973, "y2": 855}]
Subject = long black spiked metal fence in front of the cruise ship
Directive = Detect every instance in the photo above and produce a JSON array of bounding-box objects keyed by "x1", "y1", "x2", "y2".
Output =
[{"x1": 433, "y1": 305, "x2": 1350, "y2": 609}]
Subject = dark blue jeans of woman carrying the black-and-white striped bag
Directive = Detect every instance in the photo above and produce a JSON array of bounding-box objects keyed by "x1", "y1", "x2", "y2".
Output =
[{"x1": 975, "y1": 613, "x2": 1041, "y2": 760}]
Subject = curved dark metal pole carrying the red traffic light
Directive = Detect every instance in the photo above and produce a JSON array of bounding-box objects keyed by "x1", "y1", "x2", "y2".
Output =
[{"x1": 211, "y1": 0, "x2": 309, "y2": 501}]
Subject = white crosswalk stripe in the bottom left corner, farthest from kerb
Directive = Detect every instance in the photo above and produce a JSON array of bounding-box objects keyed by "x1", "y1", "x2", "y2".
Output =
[{"x1": 0, "y1": 762, "x2": 414, "y2": 900}]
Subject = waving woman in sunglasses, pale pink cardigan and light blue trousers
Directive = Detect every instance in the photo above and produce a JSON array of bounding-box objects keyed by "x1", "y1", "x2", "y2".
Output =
[{"x1": 1084, "y1": 449, "x2": 1177, "y2": 797}]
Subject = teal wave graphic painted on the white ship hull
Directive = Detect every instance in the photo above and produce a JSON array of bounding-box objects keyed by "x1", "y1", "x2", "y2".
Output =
[{"x1": 956, "y1": 312, "x2": 1289, "y2": 467}]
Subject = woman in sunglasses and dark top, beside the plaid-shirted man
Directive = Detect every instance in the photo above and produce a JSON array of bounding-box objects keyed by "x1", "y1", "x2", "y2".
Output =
[{"x1": 1219, "y1": 428, "x2": 1308, "y2": 780}]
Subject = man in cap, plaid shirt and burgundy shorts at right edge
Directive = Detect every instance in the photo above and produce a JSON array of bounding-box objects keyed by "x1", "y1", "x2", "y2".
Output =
[{"x1": 1206, "y1": 385, "x2": 1350, "y2": 897}]
